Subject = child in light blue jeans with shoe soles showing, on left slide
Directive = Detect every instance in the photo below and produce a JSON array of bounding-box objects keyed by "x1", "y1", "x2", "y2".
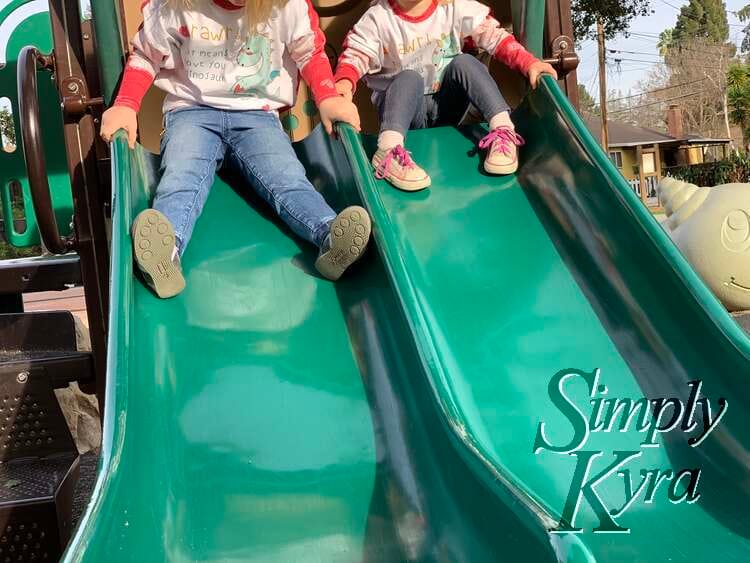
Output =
[{"x1": 101, "y1": 0, "x2": 370, "y2": 298}]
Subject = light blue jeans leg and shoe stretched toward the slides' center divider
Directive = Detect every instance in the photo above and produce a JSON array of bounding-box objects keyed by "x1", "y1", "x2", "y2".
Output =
[{"x1": 227, "y1": 111, "x2": 370, "y2": 279}]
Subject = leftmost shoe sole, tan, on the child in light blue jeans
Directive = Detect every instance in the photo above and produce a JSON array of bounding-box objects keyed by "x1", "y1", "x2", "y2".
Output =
[{"x1": 132, "y1": 209, "x2": 185, "y2": 299}]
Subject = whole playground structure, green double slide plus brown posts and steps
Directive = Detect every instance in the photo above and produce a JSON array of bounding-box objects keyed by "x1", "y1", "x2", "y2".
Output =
[{"x1": 0, "y1": 0, "x2": 750, "y2": 562}]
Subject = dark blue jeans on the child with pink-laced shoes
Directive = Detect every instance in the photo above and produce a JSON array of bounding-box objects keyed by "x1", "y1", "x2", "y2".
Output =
[{"x1": 374, "y1": 54, "x2": 510, "y2": 135}]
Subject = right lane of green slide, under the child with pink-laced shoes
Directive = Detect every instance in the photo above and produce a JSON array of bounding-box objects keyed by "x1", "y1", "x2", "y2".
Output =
[{"x1": 344, "y1": 79, "x2": 750, "y2": 561}]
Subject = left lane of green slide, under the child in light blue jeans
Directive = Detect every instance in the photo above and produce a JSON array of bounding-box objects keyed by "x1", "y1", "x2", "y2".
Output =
[{"x1": 65, "y1": 128, "x2": 552, "y2": 563}]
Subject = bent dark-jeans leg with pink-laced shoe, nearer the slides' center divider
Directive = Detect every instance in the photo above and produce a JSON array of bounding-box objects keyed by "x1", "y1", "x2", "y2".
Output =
[{"x1": 372, "y1": 70, "x2": 430, "y2": 191}]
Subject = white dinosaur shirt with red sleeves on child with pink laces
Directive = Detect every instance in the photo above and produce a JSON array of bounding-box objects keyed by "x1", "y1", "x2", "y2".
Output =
[{"x1": 336, "y1": 0, "x2": 537, "y2": 95}]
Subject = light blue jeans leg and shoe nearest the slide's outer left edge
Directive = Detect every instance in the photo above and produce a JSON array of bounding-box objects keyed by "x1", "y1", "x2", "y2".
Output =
[{"x1": 132, "y1": 108, "x2": 224, "y2": 298}]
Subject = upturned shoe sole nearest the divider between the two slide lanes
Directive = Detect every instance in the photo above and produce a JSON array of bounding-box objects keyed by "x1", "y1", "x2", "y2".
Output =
[{"x1": 315, "y1": 205, "x2": 372, "y2": 281}]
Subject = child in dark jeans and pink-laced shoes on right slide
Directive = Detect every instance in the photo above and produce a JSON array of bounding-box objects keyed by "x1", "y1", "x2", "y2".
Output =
[{"x1": 336, "y1": 0, "x2": 557, "y2": 191}]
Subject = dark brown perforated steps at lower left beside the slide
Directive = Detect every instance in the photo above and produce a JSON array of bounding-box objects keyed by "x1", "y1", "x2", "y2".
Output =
[{"x1": 0, "y1": 311, "x2": 81, "y2": 562}]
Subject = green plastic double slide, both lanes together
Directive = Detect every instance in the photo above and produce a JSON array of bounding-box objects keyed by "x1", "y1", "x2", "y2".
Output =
[{"x1": 66, "y1": 80, "x2": 750, "y2": 562}]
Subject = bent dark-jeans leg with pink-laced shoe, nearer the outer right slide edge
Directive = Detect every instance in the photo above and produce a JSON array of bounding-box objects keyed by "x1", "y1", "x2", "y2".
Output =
[{"x1": 437, "y1": 54, "x2": 523, "y2": 174}]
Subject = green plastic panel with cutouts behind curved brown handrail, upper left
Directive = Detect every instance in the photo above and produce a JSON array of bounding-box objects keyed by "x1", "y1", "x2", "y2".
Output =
[{"x1": 0, "y1": 0, "x2": 73, "y2": 247}]
